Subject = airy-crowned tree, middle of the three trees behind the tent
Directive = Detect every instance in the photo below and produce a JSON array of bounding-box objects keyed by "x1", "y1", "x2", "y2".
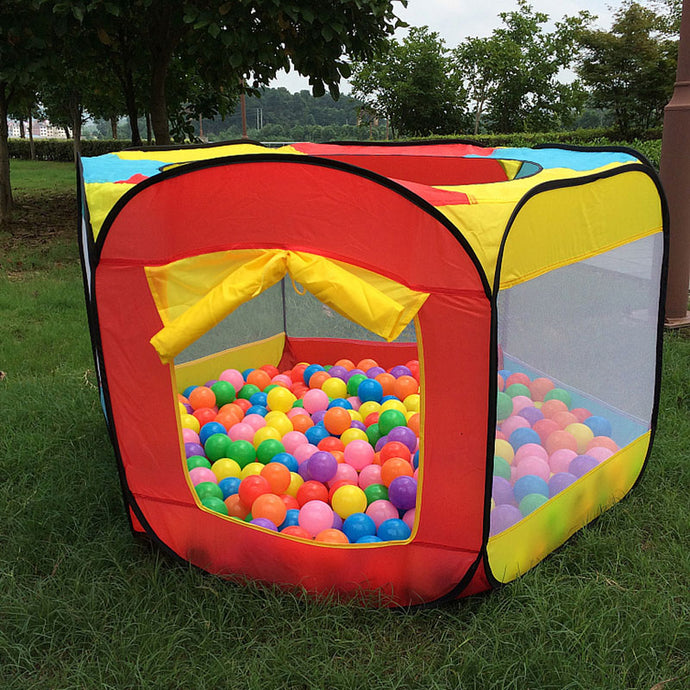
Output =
[{"x1": 454, "y1": 0, "x2": 591, "y2": 133}]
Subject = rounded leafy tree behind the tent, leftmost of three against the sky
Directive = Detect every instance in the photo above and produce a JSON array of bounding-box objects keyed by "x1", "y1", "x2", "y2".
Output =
[{"x1": 351, "y1": 26, "x2": 468, "y2": 135}]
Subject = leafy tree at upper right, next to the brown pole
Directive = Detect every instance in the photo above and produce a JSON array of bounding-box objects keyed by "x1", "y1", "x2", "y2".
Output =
[{"x1": 577, "y1": 2, "x2": 678, "y2": 137}]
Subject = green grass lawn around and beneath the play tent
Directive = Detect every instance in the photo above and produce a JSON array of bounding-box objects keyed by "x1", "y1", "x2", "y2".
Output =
[{"x1": 0, "y1": 168, "x2": 690, "y2": 690}]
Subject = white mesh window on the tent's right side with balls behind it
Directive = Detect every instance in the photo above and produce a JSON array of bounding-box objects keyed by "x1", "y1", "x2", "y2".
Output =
[{"x1": 491, "y1": 234, "x2": 663, "y2": 535}]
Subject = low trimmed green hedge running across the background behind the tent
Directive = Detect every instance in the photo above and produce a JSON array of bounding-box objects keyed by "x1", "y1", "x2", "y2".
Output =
[{"x1": 9, "y1": 129, "x2": 661, "y2": 170}]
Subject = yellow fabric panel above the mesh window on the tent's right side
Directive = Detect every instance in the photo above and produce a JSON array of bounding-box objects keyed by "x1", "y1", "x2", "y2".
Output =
[{"x1": 501, "y1": 171, "x2": 663, "y2": 289}]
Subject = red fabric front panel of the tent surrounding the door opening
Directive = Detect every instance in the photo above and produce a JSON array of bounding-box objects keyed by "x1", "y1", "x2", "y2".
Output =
[{"x1": 95, "y1": 162, "x2": 490, "y2": 604}]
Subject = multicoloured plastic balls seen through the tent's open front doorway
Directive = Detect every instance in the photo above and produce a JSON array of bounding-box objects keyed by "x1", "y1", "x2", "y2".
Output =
[{"x1": 178, "y1": 359, "x2": 419, "y2": 544}]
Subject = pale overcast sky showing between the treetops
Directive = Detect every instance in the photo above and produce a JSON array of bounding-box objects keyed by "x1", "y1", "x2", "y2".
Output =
[{"x1": 271, "y1": 0, "x2": 621, "y2": 93}]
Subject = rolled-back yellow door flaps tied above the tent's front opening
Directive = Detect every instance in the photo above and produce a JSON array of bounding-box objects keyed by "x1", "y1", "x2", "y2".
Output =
[{"x1": 146, "y1": 249, "x2": 428, "y2": 362}]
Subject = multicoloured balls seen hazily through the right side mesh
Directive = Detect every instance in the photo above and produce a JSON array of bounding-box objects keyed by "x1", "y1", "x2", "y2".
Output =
[{"x1": 490, "y1": 370, "x2": 618, "y2": 535}]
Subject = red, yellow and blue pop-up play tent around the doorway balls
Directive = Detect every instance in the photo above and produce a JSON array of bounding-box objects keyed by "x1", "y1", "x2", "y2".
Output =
[{"x1": 78, "y1": 142, "x2": 667, "y2": 605}]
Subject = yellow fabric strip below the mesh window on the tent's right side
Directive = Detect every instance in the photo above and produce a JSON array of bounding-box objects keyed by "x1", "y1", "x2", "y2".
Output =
[{"x1": 487, "y1": 432, "x2": 650, "y2": 582}]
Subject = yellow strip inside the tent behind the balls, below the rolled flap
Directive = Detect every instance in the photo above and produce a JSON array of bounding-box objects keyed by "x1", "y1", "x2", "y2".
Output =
[{"x1": 175, "y1": 333, "x2": 285, "y2": 391}]
